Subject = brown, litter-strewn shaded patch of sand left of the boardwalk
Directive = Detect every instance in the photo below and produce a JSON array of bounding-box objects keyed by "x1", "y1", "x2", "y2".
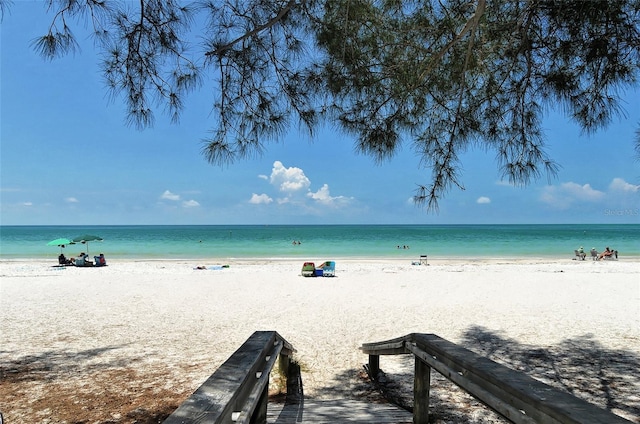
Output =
[{"x1": 0, "y1": 346, "x2": 178, "y2": 424}]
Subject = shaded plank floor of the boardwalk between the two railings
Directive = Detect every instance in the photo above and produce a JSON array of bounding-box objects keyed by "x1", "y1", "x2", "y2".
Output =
[{"x1": 267, "y1": 399, "x2": 413, "y2": 424}]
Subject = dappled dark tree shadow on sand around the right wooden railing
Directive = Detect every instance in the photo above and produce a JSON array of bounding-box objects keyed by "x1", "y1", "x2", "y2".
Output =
[{"x1": 344, "y1": 327, "x2": 640, "y2": 423}]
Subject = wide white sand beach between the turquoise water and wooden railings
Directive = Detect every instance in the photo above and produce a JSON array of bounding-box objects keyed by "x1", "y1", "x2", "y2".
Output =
[{"x1": 0, "y1": 258, "x2": 640, "y2": 424}]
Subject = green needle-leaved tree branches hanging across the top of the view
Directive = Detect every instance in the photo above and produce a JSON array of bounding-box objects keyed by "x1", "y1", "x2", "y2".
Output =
[{"x1": 8, "y1": 0, "x2": 640, "y2": 208}]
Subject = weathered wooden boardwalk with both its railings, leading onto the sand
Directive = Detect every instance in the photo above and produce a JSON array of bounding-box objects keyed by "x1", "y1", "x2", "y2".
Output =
[{"x1": 165, "y1": 331, "x2": 631, "y2": 424}]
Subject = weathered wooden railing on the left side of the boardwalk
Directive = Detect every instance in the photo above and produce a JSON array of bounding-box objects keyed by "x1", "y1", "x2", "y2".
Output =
[{"x1": 164, "y1": 331, "x2": 294, "y2": 424}]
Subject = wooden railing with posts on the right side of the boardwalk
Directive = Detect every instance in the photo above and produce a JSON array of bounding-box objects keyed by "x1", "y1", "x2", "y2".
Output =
[{"x1": 361, "y1": 333, "x2": 631, "y2": 424}]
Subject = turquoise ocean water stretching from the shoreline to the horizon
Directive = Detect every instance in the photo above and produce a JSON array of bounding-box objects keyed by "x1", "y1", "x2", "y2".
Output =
[{"x1": 0, "y1": 224, "x2": 640, "y2": 261}]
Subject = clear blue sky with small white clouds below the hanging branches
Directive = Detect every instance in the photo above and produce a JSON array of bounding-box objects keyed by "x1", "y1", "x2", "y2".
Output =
[{"x1": 0, "y1": 1, "x2": 640, "y2": 225}]
